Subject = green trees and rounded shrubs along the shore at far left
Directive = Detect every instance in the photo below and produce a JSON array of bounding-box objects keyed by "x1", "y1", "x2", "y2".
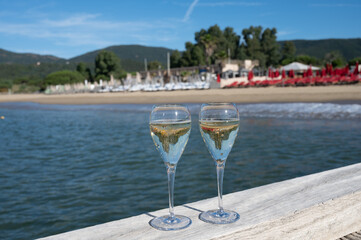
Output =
[{"x1": 0, "y1": 50, "x2": 162, "y2": 92}]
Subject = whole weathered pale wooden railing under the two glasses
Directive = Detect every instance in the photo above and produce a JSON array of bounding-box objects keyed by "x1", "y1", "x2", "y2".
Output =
[{"x1": 39, "y1": 164, "x2": 361, "y2": 240}]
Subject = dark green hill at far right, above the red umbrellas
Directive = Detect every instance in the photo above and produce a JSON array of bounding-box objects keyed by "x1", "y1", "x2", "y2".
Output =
[{"x1": 279, "y1": 38, "x2": 361, "y2": 60}]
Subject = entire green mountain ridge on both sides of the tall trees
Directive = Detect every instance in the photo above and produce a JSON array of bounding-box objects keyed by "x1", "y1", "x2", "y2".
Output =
[{"x1": 0, "y1": 38, "x2": 361, "y2": 72}]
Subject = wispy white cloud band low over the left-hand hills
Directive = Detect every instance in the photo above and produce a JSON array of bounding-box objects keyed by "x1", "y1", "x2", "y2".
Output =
[{"x1": 0, "y1": 13, "x2": 176, "y2": 48}]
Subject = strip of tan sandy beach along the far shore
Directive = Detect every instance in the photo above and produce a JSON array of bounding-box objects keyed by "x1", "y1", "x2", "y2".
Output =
[{"x1": 0, "y1": 85, "x2": 361, "y2": 104}]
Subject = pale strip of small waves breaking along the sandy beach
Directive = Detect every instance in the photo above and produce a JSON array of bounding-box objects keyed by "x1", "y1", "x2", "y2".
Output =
[{"x1": 0, "y1": 102, "x2": 361, "y2": 120}]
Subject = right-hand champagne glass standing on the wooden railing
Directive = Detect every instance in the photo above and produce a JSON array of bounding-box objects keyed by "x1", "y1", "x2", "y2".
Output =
[{"x1": 199, "y1": 103, "x2": 239, "y2": 224}]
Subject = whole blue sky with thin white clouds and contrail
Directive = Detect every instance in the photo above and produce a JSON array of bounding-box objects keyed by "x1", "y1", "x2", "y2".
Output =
[{"x1": 0, "y1": 0, "x2": 361, "y2": 58}]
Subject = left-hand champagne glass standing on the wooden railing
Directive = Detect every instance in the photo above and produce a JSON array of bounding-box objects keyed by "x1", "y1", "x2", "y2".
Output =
[{"x1": 149, "y1": 105, "x2": 192, "y2": 231}]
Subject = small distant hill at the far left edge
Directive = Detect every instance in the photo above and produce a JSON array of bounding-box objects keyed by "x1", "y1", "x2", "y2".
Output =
[{"x1": 0, "y1": 48, "x2": 66, "y2": 64}]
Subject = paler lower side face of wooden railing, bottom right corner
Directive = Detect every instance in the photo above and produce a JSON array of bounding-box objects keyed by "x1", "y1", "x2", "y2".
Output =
[{"x1": 216, "y1": 191, "x2": 361, "y2": 240}]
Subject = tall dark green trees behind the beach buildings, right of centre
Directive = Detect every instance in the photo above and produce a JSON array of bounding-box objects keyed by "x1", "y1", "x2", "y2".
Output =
[{"x1": 171, "y1": 25, "x2": 361, "y2": 68}]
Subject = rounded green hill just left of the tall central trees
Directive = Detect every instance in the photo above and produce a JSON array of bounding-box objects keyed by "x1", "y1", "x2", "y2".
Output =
[{"x1": 69, "y1": 45, "x2": 173, "y2": 69}]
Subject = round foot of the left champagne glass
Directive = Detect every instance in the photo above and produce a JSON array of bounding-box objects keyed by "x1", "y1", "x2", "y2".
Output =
[{"x1": 149, "y1": 215, "x2": 192, "y2": 231}]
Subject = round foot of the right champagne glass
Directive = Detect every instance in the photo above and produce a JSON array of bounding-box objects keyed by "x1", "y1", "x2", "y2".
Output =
[{"x1": 199, "y1": 209, "x2": 239, "y2": 224}]
